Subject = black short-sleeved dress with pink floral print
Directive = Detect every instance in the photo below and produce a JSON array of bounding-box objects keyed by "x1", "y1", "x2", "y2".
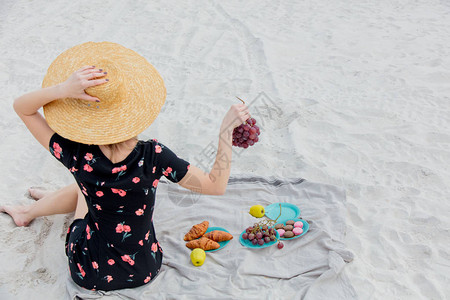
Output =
[{"x1": 50, "y1": 133, "x2": 189, "y2": 291}]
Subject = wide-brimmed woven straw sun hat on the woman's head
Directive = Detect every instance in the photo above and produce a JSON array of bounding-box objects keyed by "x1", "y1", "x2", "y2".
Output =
[{"x1": 42, "y1": 42, "x2": 166, "y2": 145}]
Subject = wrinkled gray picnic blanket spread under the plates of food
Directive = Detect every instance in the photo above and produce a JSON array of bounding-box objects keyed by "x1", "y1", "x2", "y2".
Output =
[{"x1": 67, "y1": 176, "x2": 357, "y2": 300}]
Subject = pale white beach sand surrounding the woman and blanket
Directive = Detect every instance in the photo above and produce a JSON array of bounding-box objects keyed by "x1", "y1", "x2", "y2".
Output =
[{"x1": 0, "y1": 0, "x2": 450, "y2": 299}]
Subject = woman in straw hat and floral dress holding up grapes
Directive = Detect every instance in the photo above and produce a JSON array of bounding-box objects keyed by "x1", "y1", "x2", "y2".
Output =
[{"x1": 0, "y1": 42, "x2": 249, "y2": 291}]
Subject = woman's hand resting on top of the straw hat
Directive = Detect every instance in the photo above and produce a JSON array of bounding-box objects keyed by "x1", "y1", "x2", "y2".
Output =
[{"x1": 60, "y1": 66, "x2": 108, "y2": 102}]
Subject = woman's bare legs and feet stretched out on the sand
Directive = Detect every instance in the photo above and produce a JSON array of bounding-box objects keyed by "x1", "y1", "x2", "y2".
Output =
[{"x1": 0, "y1": 183, "x2": 79, "y2": 226}]
